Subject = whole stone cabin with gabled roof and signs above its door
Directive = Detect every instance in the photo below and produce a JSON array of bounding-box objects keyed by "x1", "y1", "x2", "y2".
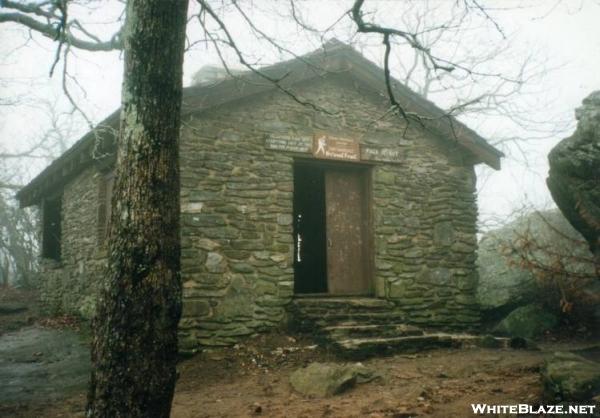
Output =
[{"x1": 17, "y1": 41, "x2": 502, "y2": 350}]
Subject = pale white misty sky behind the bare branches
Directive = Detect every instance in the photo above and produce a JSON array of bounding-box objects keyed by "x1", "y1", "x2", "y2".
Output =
[{"x1": 0, "y1": 0, "x2": 600, "y2": 229}]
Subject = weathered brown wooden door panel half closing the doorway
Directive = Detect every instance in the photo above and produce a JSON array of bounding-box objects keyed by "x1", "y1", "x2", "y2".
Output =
[{"x1": 325, "y1": 169, "x2": 371, "y2": 295}]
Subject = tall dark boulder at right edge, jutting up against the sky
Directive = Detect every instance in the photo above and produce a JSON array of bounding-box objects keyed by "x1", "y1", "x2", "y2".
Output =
[{"x1": 546, "y1": 91, "x2": 600, "y2": 278}]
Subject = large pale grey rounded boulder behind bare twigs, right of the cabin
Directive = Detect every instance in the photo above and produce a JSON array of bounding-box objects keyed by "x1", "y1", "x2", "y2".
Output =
[{"x1": 477, "y1": 210, "x2": 595, "y2": 321}]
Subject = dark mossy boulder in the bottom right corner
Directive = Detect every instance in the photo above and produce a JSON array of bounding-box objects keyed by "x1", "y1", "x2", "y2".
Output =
[{"x1": 542, "y1": 352, "x2": 600, "y2": 402}]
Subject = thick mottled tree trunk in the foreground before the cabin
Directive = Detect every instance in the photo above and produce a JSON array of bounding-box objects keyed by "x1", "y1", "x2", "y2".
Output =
[{"x1": 87, "y1": 0, "x2": 188, "y2": 418}]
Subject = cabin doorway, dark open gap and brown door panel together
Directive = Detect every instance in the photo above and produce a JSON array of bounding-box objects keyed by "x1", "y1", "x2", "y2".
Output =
[{"x1": 294, "y1": 161, "x2": 372, "y2": 295}]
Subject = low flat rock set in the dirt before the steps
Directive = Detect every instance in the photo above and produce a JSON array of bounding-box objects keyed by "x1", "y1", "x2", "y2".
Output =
[{"x1": 290, "y1": 363, "x2": 377, "y2": 398}]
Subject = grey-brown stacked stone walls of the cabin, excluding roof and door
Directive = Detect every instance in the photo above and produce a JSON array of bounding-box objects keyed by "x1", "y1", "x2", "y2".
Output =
[{"x1": 37, "y1": 74, "x2": 478, "y2": 351}]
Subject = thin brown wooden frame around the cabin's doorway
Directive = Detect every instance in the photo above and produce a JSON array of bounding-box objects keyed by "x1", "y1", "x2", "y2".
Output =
[{"x1": 293, "y1": 158, "x2": 376, "y2": 297}]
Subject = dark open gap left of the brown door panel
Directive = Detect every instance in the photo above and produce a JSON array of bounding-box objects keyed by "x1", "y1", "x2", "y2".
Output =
[{"x1": 294, "y1": 163, "x2": 327, "y2": 294}]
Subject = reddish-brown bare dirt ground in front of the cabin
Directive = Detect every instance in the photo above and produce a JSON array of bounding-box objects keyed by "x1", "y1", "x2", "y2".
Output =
[{"x1": 0, "y1": 288, "x2": 596, "y2": 418}]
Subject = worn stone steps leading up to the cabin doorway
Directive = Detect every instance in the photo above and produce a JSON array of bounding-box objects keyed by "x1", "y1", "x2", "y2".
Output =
[{"x1": 289, "y1": 297, "x2": 509, "y2": 359}]
